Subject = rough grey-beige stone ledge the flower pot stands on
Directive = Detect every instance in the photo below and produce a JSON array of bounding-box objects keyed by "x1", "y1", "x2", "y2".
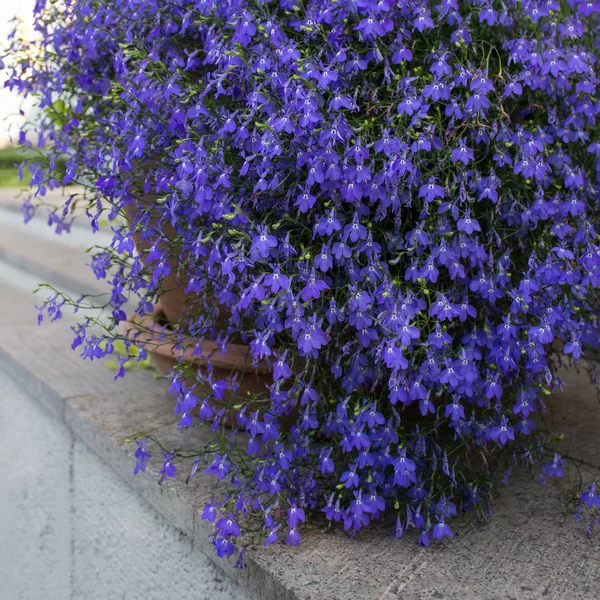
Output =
[{"x1": 0, "y1": 324, "x2": 600, "y2": 600}]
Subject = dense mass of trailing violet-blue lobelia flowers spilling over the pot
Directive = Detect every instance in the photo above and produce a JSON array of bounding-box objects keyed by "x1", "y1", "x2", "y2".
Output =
[{"x1": 8, "y1": 0, "x2": 600, "y2": 556}]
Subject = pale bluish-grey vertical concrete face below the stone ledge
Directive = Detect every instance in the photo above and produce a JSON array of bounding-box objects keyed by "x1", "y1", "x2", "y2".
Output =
[{"x1": 0, "y1": 354, "x2": 250, "y2": 600}]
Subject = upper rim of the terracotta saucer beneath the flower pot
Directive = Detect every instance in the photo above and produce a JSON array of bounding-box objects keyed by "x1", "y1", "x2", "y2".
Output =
[{"x1": 121, "y1": 313, "x2": 273, "y2": 374}]
